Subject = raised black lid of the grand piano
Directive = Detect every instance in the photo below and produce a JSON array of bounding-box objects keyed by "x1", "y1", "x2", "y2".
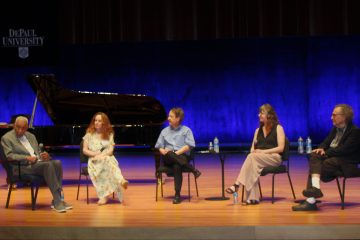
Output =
[{"x1": 28, "y1": 74, "x2": 167, "y2": 125}]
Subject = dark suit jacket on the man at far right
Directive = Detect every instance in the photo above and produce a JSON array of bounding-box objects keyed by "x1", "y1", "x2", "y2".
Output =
[{"x1": 319, "y1": 124, "x2": 360, "y2": 163}]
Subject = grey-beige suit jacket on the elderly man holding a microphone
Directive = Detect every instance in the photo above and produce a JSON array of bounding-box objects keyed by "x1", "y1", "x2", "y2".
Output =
[{"x1": 1, "y1": 129, "x2": 39, "y2": 161}]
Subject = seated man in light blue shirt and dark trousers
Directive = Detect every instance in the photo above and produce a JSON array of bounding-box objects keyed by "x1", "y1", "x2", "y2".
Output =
[{"x1": 155, "y1": 108, "x2": 201, "y2": 204}]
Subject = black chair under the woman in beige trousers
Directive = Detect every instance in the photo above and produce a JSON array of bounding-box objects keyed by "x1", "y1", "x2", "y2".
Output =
[{"x1": 241, "y1": 138, "x2": 296, "y2": 203}]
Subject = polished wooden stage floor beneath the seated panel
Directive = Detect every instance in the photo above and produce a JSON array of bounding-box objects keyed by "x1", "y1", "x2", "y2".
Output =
[{"x1": 0, "y1": 152, "x2": 360, "y2": 240}]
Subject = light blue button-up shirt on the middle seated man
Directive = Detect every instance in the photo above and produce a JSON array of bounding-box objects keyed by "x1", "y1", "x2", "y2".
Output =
[{"x1": 155, "y1": 125, "x2": 195, "y2": 151}]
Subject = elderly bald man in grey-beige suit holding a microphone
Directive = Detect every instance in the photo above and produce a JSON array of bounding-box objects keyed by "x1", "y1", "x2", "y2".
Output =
[{"x1": 1, "y1": 116, "x2": 72, "y2": 212}]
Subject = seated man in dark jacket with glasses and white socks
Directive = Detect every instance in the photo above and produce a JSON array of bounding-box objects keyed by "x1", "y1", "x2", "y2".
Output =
[{"x1": 292, "y1": 104, "x2": 360, "y2": 211}]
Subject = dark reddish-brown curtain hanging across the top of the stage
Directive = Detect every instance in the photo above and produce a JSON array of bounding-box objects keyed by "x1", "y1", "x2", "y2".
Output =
[{"x1": 58, "y1": 0, "x2": 360, "y2": 44}]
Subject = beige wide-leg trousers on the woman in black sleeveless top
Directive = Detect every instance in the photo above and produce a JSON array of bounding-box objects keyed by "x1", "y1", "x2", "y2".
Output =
[{"x1": 235, "y1": 153, "x2": 281, "y2": 201}]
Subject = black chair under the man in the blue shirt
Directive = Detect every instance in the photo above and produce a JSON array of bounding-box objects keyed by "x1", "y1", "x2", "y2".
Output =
[{"x1": 154, "y1": 149, "x2": 199, "y2": 202}]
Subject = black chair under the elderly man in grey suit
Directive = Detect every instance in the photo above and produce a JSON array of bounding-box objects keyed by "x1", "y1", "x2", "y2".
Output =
[{"x1": 0, "y1": 145, "x2": 44, "y2": 210}]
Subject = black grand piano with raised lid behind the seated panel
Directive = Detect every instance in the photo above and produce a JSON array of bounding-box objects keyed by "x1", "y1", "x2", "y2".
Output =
[{"x1": 22, "y1": 74, "x2": 167, "y2": 147}]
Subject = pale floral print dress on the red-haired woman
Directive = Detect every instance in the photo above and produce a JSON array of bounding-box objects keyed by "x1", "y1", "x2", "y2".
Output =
[{"x1": 83, "y1": 133, "x2": 125, "y2": 202}]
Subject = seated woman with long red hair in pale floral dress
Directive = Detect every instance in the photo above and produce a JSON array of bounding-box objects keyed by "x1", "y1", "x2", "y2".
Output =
[{"x1": 83, "y1": 112, "x2": 129, "y2": 205}]
